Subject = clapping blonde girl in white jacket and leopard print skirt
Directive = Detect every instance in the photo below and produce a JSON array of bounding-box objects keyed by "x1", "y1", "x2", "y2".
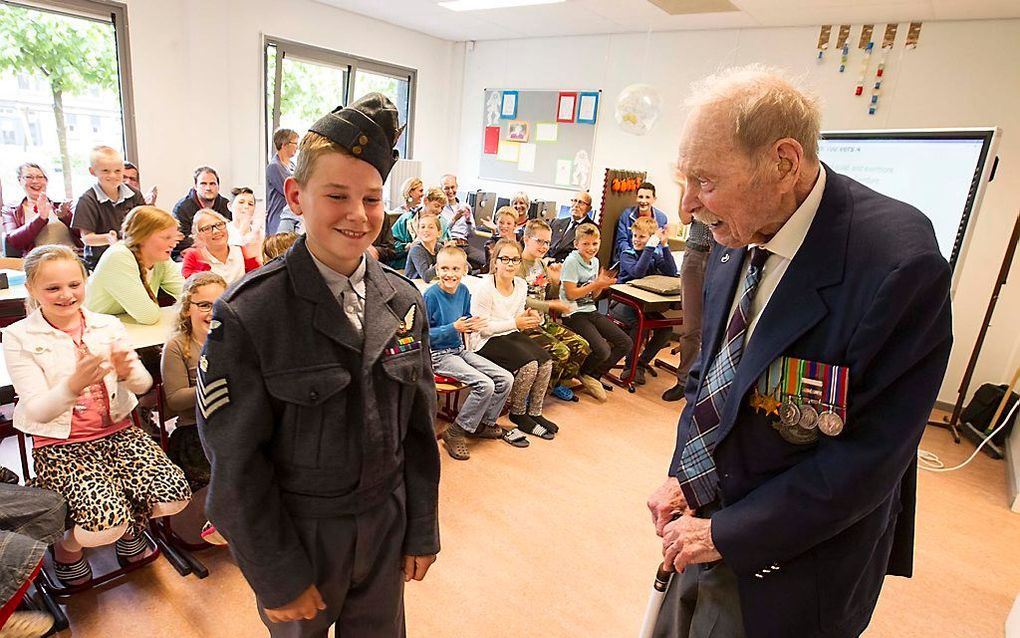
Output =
[{"x1": 3, "y1": 246, "x2": 191, "y2": 586}]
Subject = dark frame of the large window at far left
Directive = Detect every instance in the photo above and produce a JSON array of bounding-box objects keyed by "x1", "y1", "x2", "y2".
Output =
[{"x1": 0, "y1": 0, "x2": 139, "y2": 162}]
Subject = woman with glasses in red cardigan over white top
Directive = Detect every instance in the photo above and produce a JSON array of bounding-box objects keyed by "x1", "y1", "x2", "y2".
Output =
[{"x1": 181, "y1": 208, "x2": 259, "y2": 286}]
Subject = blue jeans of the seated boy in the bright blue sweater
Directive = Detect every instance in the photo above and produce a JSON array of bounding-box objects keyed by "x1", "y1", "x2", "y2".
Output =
[{"x1": 432, "y1": 348, "x2": 513, "y2": 432}]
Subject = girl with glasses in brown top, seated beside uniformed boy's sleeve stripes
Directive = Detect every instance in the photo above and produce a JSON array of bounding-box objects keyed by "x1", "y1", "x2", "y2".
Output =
[{"x1": 159, "y1": 271, "x2": 227, "y2": 544}]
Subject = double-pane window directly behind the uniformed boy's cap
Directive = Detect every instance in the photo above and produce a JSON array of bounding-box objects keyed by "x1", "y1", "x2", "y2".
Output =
[{"x1": 265, "y1": 38, "x2": 417, "y2": 164}]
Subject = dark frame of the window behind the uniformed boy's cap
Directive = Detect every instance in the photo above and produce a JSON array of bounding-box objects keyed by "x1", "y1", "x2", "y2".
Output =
[{"x1": 267, "y1": 34, "x2": 418, "y2": 163}]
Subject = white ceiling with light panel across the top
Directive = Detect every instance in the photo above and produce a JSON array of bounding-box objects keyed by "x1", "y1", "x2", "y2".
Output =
[{"x1": 316, "y1": 0, "x2": 1020, "y2": 41}]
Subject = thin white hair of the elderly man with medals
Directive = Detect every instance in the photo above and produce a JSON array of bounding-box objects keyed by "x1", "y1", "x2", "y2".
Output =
[{"x1": 686, "y1": 64, "x2": 822, "y2": 161}]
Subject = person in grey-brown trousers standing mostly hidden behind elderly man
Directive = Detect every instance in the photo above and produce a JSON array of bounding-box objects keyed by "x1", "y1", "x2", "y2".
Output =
[{"x1": 662, "y1": 214, "x2": 715, "y2": 401}]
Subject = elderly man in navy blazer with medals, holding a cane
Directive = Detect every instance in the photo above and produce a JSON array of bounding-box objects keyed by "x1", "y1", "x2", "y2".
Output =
[{"x1": 648, "y1": 66, "x2": 952, "y2": 638}]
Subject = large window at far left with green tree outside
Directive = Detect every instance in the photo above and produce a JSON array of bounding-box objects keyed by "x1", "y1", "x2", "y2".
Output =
[{"x1": 0, "y1": 0, "x2": 137, "y2": 201}]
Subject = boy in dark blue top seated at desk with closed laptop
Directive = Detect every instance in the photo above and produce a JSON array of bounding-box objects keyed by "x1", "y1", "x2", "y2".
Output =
[{"x1": 609, "y1": 217, "x2": 676, "y2": 385}]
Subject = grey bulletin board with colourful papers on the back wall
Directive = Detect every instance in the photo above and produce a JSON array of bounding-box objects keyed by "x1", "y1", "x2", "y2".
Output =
[{"x1": 478, "y1": 89, "x2": 603, "y2": 191}]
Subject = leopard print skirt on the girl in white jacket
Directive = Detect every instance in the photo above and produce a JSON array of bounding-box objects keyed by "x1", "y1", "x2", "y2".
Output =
[{"x1": 32, "y1": 426, "x2": 192, "y2": 536}]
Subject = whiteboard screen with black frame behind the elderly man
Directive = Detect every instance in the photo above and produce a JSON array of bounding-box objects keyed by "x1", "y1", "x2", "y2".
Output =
[{"x1": 818, "y1": 128, "x2": 1002, "y2": 284}]
